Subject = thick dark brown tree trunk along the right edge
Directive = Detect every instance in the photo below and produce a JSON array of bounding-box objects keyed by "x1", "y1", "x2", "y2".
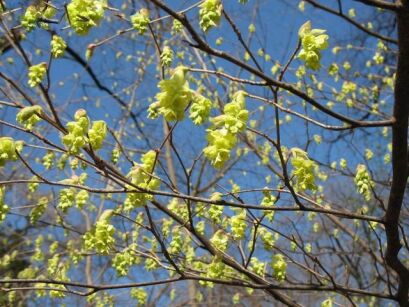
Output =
[{"x1": 385, "y1": 1, "x2": 409, "y2": 306}]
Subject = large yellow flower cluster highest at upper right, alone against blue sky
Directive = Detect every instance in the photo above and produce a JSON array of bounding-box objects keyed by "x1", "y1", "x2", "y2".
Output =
[{"x1": 298, "y1": 21, "x2": 328, "y2": 70}]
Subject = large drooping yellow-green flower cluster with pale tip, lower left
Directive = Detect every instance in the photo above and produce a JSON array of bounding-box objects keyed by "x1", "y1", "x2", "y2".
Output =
[{"x1": 84, "y1": 210, "x2": 115, "y2": 254}]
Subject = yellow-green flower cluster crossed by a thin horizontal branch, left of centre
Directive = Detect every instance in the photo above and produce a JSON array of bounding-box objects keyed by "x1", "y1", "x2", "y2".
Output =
[{"x1": 124, "y1": 150, "x2": 160, "y2": 211}]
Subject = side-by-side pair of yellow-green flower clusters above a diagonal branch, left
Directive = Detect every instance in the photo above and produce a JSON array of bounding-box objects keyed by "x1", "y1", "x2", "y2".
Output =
[{"x1": 62, "y1": 109, "x2": 108, "y2": 154}]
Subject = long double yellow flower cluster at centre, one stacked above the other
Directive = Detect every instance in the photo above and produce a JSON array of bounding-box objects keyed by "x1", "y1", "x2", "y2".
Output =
[{"x1": 203, "y1": 91, "x2": 249, "y2": 168}]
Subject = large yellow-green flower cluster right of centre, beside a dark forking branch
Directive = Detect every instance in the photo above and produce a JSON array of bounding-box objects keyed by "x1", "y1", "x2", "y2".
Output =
[{"x1": 291, "y1": 148, "x2": 318, "y2": 191}]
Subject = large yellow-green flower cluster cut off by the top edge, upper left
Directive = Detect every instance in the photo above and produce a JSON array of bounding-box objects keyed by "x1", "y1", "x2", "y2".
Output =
[{"x1": 67, "y1": 0, "x2": 106, "y2": 35}]
